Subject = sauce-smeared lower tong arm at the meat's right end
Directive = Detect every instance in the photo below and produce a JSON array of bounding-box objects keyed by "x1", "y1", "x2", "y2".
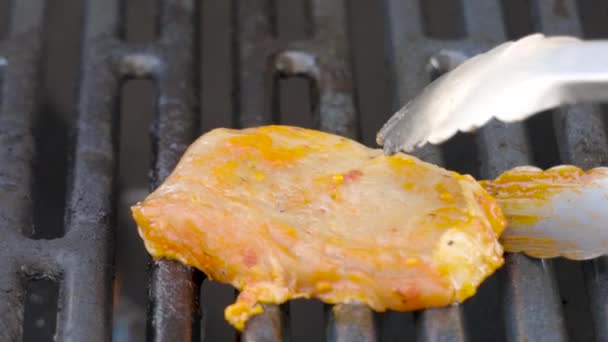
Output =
[{"x1": 480, "y1": 165, "x2": 608, "y2": 260}]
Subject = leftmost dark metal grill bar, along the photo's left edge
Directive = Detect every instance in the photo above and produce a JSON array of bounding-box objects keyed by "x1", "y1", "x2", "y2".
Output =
[{"x1": 0, "y1": 0, "x2": 44, "y2": 341}]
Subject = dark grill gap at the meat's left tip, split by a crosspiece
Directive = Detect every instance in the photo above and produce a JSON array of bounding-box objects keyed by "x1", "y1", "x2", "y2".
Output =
[{"x1": 113, "y1": 0, "x2": 159, "y2": 342}]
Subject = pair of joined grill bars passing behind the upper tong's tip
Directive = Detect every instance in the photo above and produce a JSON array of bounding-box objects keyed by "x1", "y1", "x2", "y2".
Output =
[{"x1": 386, "y1": 0, "x2": 565, "y2": 341}]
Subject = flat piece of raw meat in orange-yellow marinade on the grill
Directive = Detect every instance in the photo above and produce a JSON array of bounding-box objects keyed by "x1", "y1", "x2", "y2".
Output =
[{"x1": 132, "y1": 126, "x2": 505, "y2": 329}]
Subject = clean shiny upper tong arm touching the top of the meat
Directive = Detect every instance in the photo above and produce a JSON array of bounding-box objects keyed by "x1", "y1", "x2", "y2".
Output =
[{"x1": 376, "y1": 34, "x2": 608, "y2": 154}]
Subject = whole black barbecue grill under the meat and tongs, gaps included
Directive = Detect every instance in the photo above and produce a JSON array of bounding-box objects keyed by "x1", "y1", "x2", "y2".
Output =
[{"x1": 0, "y1": 0, "x2": 608, "y2": 341}]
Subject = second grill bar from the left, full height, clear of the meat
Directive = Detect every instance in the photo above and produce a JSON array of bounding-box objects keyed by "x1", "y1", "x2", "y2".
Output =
[{"x1": 57, "y1": 2, "x2": 118, "y2": 341}]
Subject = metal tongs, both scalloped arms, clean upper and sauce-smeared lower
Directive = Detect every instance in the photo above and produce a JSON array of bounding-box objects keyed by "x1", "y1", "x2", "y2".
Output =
[{"x1": 377, "y1": 34, "x2": 608, "y2": 260}]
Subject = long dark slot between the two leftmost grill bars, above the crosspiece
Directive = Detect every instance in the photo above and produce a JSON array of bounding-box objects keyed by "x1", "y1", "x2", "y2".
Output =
[{"x1": 32, "y1": 0, "x2": 82, "y2": 239}]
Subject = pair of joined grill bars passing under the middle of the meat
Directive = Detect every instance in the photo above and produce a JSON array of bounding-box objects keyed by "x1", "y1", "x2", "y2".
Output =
[{"x1": 236, "y1": 0, "x2": 376, "y2": 341}]
